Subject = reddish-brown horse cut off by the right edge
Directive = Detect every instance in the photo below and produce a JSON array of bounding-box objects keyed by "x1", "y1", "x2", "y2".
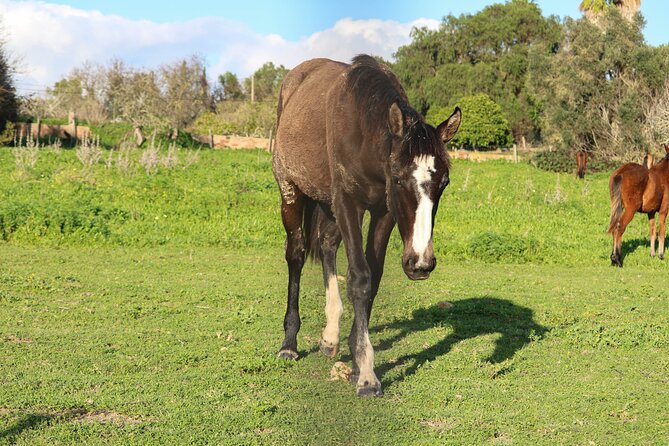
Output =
[{"x1": 609, "y1": 145, "x2": 669, "y2": 266}]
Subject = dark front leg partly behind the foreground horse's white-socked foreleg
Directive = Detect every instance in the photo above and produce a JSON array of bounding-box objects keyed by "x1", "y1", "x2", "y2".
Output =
[{"x1": 365, "y1": 211, "x2": 395, "y2": 323}]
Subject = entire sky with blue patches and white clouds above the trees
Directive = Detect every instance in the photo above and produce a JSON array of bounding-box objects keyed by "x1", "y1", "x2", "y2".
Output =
[{"x1": 0, "y1": 0, "x2": 669, "y2": 89}]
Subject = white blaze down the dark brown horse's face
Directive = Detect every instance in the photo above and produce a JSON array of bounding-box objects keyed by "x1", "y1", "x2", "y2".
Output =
[{"x1": 411, "y1": 155, "x2": 434, "y2": 267}]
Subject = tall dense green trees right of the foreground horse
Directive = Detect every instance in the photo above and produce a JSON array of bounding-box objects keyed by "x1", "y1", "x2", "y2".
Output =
[{"x1": 395, "y1": 0, "x2": 669, "y2": 158}]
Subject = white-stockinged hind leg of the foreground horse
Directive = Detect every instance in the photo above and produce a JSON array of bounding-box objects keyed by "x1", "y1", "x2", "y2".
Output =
[{"x1": 319, "y1": 213, "x2": 344, "y2": 358}]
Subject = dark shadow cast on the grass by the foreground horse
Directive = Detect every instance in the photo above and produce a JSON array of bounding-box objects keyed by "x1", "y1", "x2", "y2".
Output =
[{"x1": 371, "y1": 296, "x2": 547, "y2": 385}]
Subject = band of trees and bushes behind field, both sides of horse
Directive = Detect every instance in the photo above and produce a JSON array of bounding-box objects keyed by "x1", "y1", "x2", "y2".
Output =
[{"x1": 0, "y1": 0, "x2": 669, "y2": 167}]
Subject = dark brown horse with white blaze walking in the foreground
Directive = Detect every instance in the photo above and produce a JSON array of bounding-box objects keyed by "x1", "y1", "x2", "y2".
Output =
[{"x1": 272, "y1": 56, "x2": 461, "y2": 396}]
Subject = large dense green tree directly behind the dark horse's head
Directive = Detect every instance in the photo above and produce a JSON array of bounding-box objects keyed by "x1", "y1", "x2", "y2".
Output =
[{"x1": 394, "y1": 0, "x2": 560, "y2": 140}]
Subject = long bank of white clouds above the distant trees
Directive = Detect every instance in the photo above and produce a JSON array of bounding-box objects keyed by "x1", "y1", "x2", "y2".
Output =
[{"x1": 0, "y1": 0, "x2": 439, "y2": 90}]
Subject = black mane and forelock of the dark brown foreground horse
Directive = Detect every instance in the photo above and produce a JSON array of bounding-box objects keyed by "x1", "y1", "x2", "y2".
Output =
[{"x1": 346, "y1": 54, "x2": 442, "y2": 162}]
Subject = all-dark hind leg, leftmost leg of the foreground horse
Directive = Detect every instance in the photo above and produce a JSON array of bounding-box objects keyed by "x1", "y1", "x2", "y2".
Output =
[{"x1": 279, "y1": 184, "x2": 305, "y2": 359}]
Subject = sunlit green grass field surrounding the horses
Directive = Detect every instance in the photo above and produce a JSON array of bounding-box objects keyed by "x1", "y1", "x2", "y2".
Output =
[{"x1": 0, "y1": 148, "x2": 669, "y2": 445}]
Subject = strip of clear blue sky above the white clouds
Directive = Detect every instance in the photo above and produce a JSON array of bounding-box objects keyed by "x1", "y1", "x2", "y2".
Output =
[{"x1": 43, "y1": 0, "x2": 669, "y2": 45}]
